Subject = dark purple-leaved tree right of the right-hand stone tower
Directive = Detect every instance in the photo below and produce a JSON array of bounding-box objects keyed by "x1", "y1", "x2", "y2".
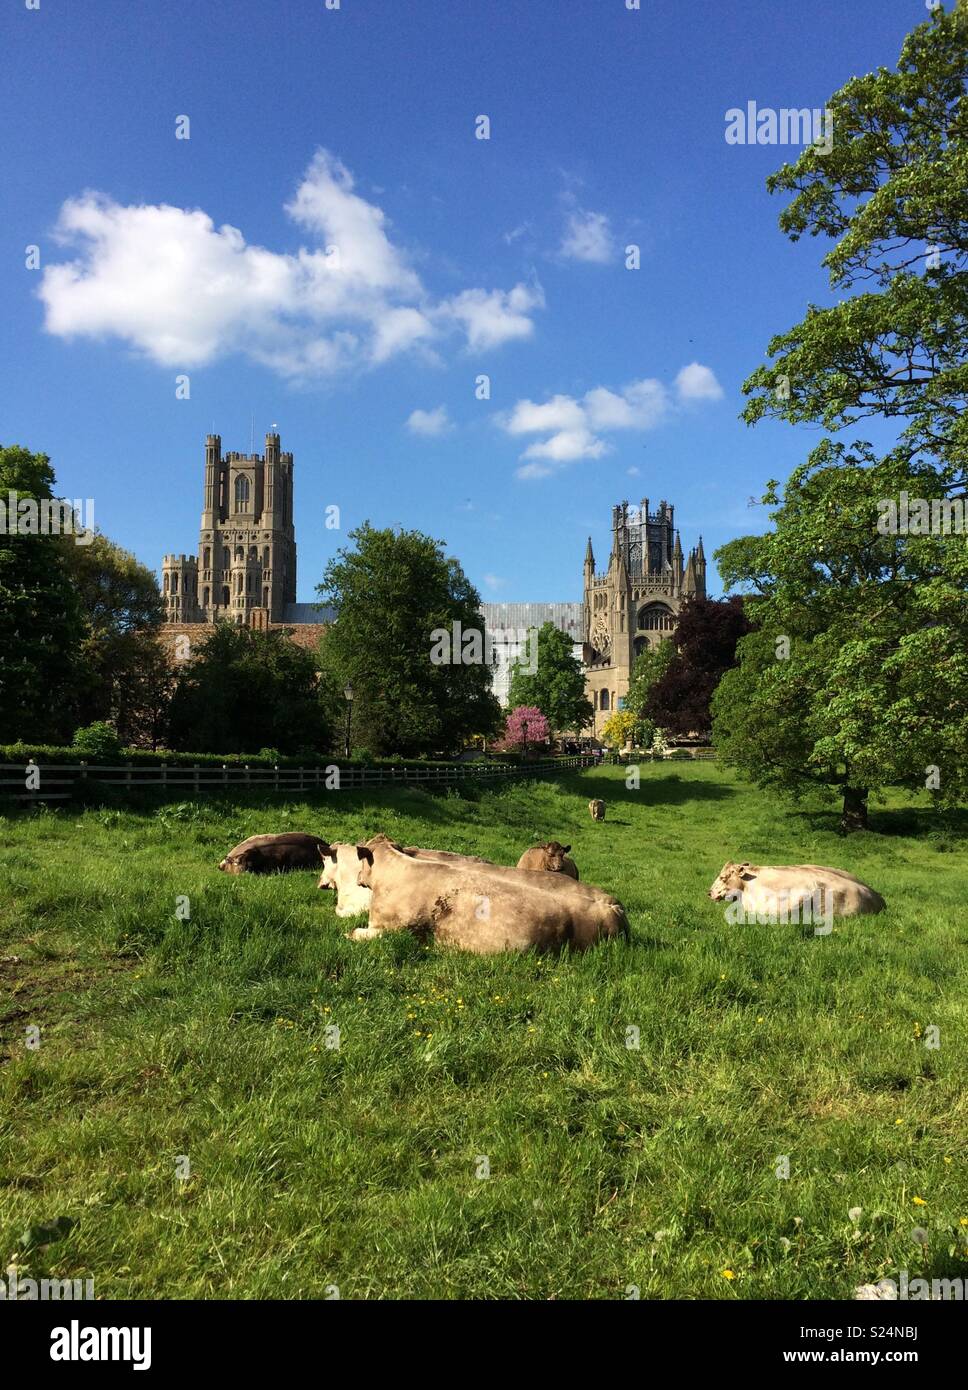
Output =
[{"x1": 645, "y1": 596, "x2": 750, "y2": 735}]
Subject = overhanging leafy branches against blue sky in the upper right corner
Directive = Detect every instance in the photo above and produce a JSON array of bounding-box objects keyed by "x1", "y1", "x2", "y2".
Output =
[{"x1": 744, "y1": 0, "x2": 968, "y2": 491}]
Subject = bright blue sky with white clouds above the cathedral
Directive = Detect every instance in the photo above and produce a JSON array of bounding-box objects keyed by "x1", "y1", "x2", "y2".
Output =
[{"x1": 0, "y1": 0, "x2": 926, "y2": 600}]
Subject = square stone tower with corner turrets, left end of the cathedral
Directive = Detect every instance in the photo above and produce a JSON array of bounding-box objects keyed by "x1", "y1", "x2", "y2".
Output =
[{"x1": 161, "y1": 434, "x2": 296, "y2": 627}]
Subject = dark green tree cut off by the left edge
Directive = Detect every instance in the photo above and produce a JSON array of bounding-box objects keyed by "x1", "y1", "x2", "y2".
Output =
[{"x1": 0, "y1": 445, "x2": 83, "y2": 742}]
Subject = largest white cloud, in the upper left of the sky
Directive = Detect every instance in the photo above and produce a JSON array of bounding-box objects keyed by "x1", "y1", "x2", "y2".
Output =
[{"x1": 39, "y1": 150, "x2": 544, "y2": 379}]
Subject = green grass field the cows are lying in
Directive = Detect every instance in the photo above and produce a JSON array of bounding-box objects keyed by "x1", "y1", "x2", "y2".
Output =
[{"x1": 0, "y1": 765, "x2": 968, "y2": 1300}]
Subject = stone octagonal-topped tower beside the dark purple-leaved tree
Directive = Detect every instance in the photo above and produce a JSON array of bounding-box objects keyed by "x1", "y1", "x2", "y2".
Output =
[{"x1": 584, "y1": 498, "x2": 705, "y2": 735}]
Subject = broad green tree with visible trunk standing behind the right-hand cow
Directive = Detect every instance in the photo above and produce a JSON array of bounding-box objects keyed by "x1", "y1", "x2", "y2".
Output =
[{"x1": 712, "y1": 441, "x2": 968, "y2": 831}]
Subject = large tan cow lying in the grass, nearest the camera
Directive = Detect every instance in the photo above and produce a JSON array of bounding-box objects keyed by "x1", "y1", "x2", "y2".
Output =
[{"x1": 348, "y1": 840, "x2": 629, "y2": 955}]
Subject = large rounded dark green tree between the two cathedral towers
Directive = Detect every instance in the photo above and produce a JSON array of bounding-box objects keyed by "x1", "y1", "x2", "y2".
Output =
[{"x1": 318, "y1": 523, "x2": 501, "y2": 756}]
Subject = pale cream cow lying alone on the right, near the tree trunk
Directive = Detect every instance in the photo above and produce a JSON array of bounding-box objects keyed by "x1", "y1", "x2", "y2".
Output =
[{"x1": 709, "y1": 862, "x2": 886, "y2": 920}]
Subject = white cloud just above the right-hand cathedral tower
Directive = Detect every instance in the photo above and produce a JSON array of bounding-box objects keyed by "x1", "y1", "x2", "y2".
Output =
[{"x1": 506, "y1": 363, "x2": 722, "y2": 478}]
